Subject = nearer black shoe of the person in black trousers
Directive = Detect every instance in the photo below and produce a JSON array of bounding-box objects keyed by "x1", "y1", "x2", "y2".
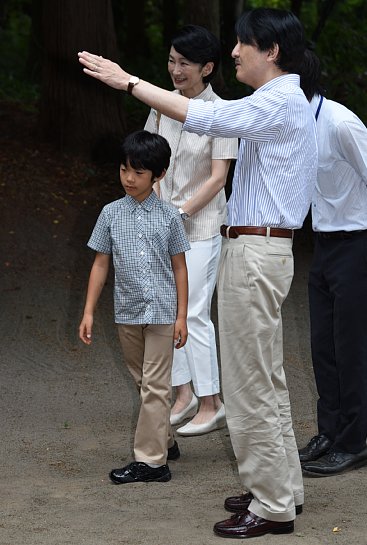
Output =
[{"x1": 302, "y1": 447, "x2": 367, "y2": 477}]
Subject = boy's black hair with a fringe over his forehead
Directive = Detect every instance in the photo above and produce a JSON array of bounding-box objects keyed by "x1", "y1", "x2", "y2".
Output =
[{"x1": 120, "y1": 131, "x2": 171, "y2": 177}]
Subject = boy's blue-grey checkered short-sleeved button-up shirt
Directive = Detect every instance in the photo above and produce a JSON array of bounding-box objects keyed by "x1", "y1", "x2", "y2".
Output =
[{"x1": 88, "y1": 192, "x2": 190, "y2": 324}]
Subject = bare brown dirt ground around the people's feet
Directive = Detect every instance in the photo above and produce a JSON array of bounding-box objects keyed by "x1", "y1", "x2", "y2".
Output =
[{"x1": 0, "y1": 104, "x2": 367, "y2": 545}]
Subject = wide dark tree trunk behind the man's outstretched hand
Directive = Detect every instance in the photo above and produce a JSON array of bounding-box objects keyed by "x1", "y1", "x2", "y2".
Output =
[{"x1": 39, "y1": 0, "x2": 125, "y2": 160}]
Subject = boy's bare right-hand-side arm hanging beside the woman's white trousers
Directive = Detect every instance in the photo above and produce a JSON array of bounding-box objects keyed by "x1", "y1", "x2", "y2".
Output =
[{"x1": 171, "y1": 252, "x2": 188, "y2": 348}]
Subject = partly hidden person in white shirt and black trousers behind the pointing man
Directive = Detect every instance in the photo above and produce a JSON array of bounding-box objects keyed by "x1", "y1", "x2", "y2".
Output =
[{"x1": 299, "y1": 54, "x2": 367, "y2": 477}]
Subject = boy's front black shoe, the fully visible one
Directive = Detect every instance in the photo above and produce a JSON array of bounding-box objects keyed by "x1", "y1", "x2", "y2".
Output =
[{"x1": 110, "y1": 462, "x2": 171, "y2": 484}]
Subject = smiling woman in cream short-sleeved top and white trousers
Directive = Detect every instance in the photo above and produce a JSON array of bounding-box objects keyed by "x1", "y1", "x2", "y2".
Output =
[{"x1": 145, "y1": 25, "x2": 238, "y2": 435}]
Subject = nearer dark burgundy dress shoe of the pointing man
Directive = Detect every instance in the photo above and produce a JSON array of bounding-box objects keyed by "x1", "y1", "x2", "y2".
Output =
[{"x1": 214, "y1": 511, "x2": 294, "y2": 538}]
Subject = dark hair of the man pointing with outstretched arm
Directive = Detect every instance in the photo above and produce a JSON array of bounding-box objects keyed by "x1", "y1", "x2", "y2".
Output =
[{"x1": 236, "y1": 8, "x2": 306, "y2": 73}]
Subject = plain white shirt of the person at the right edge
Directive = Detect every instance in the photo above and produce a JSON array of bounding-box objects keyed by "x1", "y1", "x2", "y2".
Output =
[{"x1": 311, "y1": 96, "x2": 367, "y2": 232}]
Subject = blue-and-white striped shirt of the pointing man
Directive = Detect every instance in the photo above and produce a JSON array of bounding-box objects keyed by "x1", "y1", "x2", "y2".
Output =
[{"x1": 184, "y1": 74, "x2": 317, "y2": 229}]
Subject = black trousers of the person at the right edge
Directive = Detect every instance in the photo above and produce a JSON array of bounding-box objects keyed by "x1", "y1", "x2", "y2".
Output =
[{"x1": 309, "y1": 231, "x2": 367, "y2": 453}]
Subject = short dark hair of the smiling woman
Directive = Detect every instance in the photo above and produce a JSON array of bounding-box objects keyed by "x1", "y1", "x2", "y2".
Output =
[{"x1": 171, "y1": 25, "x2": 220, "y2": 83}]
